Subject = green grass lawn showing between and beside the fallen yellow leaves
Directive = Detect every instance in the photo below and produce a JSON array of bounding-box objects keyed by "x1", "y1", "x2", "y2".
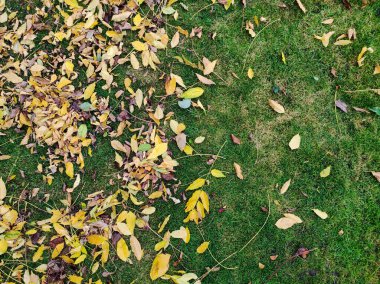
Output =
[{"x1": 0, "y1": 0, "x2": 380, "y2": 283}]
